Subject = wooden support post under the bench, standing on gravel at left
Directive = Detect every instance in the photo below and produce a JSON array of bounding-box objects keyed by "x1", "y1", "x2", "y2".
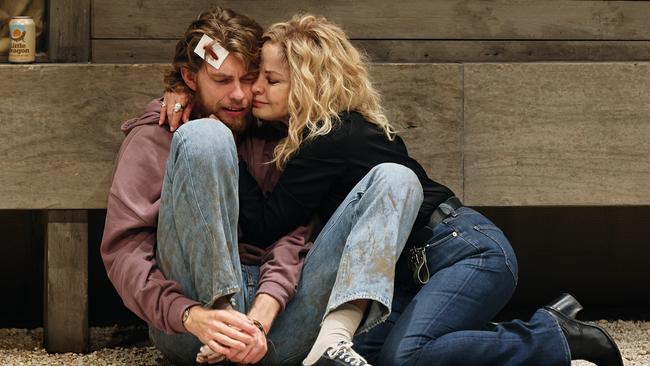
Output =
[{"x1": 43, "y1": 210, "x2": 88, "y2": 353}]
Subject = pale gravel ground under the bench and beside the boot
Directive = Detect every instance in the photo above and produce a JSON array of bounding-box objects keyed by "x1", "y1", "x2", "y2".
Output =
[{"x1": 0, "y1": 320, "x2": 650, "y2": 366}]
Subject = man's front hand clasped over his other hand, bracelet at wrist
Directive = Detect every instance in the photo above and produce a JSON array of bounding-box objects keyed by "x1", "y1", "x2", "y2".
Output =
[{"x1": 184, "y1": 306, "x2": 259, "y2": 358}]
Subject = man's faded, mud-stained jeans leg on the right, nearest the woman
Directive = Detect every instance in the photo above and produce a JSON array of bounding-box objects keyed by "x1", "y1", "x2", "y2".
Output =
[{"x1": 264, "y1": 164, "x2": 423, "y2": 365}]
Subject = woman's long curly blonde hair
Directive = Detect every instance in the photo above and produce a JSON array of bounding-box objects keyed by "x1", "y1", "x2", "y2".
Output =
[{"x1": 262, "y1": 15, "x2": 395, "y2": 169}]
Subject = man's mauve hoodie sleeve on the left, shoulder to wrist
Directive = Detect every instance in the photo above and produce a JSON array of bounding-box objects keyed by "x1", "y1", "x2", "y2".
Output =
[{"x1": 101, "y1": 125, "x2": 199, "y2": 334}]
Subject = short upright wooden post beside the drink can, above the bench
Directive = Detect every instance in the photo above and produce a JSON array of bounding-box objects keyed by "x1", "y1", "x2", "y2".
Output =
[{"x1": 48, "y1": 0, "x2": 90, "y2": 62}]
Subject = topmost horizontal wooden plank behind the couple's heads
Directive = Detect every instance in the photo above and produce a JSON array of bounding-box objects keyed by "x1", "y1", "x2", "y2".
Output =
[{"x1": 92, "y1": 0, "x2": 650, "y2": 40}]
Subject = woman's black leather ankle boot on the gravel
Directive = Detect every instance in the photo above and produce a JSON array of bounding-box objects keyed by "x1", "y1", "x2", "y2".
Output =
[{"x1": 544, "y1": 307, "x2": 623, "y2": 366}]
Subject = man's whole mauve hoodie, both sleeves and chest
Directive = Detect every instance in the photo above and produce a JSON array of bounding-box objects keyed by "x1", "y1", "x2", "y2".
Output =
[{"x1": 101, "y1": 99, "x2": 312, "y2": 334}]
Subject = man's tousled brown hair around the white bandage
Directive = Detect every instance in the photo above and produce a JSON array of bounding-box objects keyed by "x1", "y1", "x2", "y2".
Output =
[{"x1": 164, "y1": 7, "x2": 264, "y2": 94}]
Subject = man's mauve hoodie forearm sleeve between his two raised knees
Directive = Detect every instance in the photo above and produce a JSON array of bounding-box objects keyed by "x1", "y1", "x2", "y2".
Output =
[{"x1": 257, "y1": 224, "x2": 313, "y2": 310}]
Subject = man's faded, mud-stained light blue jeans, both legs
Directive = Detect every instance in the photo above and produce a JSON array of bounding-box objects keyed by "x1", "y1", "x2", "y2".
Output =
[{"x1": 150, "y1": 119, "x2": 422, "y2": 365}]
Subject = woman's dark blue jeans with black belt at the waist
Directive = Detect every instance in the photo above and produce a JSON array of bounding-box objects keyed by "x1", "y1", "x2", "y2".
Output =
[{"x1": 355, "y1": 207, "x2": 571, "y2": 366}]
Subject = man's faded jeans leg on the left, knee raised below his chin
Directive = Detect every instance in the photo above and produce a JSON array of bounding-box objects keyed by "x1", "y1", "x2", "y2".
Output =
[{"x1": 149, "y1": 119, "x2": 247, "y2": 365}]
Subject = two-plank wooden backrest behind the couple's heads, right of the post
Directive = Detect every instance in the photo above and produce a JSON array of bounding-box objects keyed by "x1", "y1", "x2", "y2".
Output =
[{"x1": 91, "y1": 0, "x2": 650, "y2": 63}]
